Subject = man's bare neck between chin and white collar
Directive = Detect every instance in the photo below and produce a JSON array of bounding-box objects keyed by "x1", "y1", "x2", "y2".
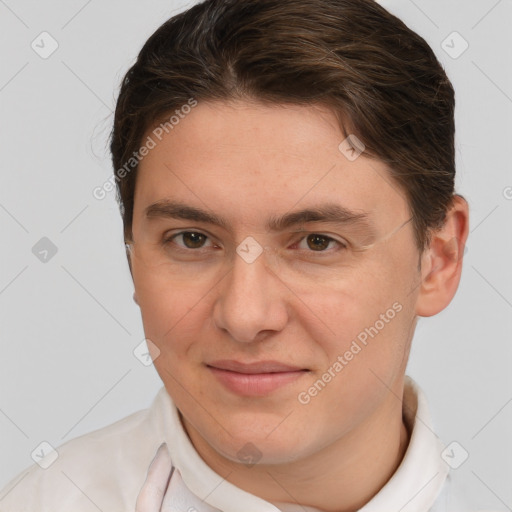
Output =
[{"x1": 184, "y1": 384, "x2": 409, "y2": 512}]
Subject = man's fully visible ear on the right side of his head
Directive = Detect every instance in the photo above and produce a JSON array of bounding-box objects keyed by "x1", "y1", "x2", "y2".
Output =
[{"x1": 416, "y1": 195, "x2": 469, "y2": 316}]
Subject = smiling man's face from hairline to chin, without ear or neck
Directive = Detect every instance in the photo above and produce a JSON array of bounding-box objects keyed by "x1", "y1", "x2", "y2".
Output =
[{"x1": 131, "y1": 102, "x2": 419, "y2": 463}]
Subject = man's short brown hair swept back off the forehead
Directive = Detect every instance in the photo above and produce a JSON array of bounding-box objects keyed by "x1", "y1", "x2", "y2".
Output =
[{"x1": 110, "y1": 0, "x2": 455, "y2": 250}]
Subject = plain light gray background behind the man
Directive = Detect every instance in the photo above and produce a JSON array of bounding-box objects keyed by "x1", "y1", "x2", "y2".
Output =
[{"x1": 0, "y1": 0, "x2": 512, "y2": 511}]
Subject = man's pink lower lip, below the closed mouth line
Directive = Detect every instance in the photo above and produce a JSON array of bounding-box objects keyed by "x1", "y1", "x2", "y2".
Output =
[{"x1": 208, "y1": 366, "x2": 307, "y2": 396}]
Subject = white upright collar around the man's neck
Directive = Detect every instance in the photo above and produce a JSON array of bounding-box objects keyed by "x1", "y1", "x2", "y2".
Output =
[{"x1": 148, "y1": 377, "x2": 449, "y2": 512}]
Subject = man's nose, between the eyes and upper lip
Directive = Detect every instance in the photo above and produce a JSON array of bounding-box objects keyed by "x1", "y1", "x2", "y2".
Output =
[{"x1": 213, "y1": 246, "x2": 288, "y2": 343}]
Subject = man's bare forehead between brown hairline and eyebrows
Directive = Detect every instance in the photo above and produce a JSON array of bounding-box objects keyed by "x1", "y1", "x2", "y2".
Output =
[{"x1": 134, "y1": 101, "x2": 408, "y2": 230}]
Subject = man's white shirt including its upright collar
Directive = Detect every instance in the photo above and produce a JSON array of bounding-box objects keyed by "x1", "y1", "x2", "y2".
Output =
[{"x1": 0, "y1": 377, "x2": 480, "y2": 512}]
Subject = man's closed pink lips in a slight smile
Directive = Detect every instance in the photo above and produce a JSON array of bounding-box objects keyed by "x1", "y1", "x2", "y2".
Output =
[{"x1": 206, "y1": 360, "x2": 309, "y2": 396}]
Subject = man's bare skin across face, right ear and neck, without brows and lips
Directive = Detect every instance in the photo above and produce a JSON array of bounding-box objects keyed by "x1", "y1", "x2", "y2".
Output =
[{"x1": 130, "y1": 100, "x2": 468, "y2": 512}]
